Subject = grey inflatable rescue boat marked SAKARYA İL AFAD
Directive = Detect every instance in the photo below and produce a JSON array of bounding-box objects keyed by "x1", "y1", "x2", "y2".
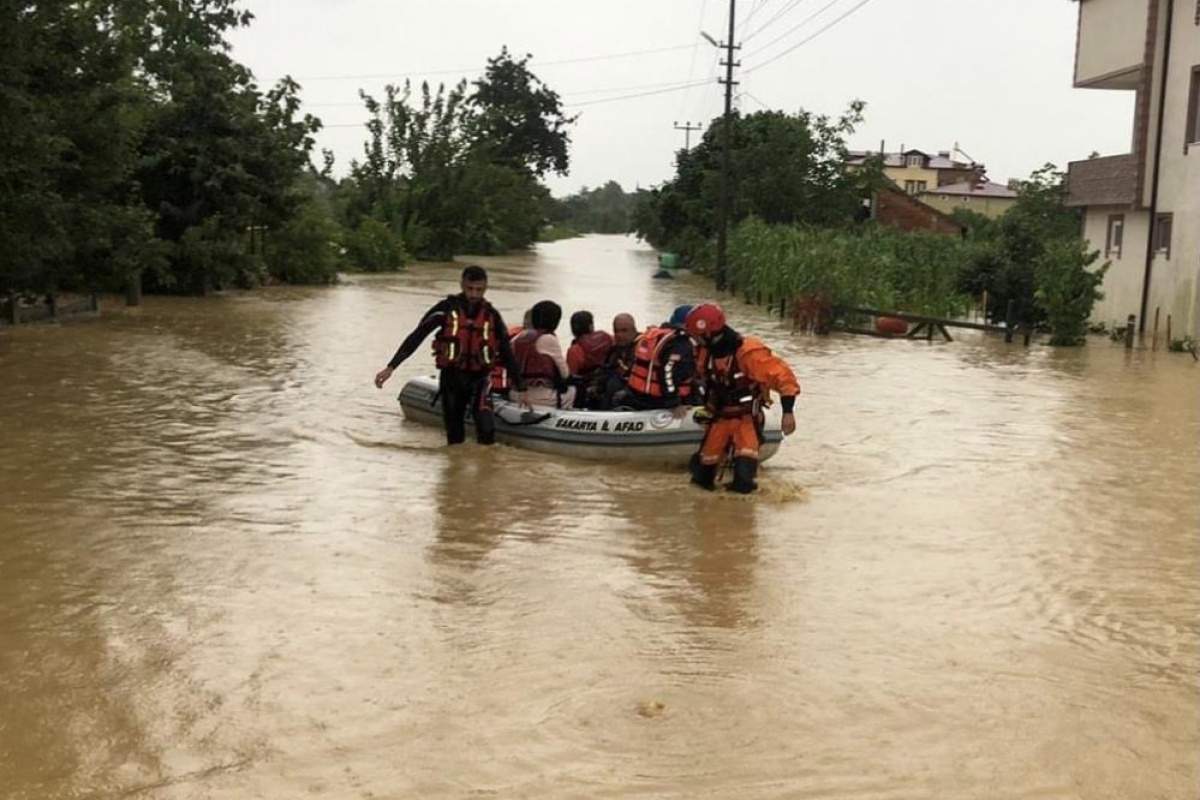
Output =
[{"x1": 400, "y1": 377, "x2": 784, "y2": 464}]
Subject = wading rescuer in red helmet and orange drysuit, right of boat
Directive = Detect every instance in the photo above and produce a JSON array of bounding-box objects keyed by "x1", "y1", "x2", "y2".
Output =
[{"x1": 684, "y1": 303, "x2": 800, "y2": 494}]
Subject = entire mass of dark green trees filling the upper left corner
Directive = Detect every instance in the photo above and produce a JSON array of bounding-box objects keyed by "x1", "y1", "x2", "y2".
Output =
[{"x1": 0, "y1": 0, "x2": 332, "y2": 294}]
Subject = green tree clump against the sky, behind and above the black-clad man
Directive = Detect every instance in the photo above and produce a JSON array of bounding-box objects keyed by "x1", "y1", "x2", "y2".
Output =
[{"x1": 338, "y1": 50, "x2": 574, "y2": 259}]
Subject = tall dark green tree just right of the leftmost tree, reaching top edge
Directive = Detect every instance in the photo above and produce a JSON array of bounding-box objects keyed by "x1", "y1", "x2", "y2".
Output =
[{"x1": 138, "y1": 0, "x2": 320, "y2": 293}]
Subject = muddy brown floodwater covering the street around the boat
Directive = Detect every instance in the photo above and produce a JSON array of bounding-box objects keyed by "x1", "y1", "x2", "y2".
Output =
[{"x1": 0, "y1": 236, "x2": 1200, "y2": 800}]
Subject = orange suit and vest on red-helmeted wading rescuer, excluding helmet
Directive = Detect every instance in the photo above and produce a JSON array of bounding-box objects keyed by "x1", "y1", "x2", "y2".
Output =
[{"x1": 700, "y1": 336, "x2": 800, "y2": 465}]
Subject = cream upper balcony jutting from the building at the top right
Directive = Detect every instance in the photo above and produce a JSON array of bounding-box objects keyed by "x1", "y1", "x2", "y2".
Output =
[{"x1": 1075, "y1": 0, "x2": 1148, "y2": 90}]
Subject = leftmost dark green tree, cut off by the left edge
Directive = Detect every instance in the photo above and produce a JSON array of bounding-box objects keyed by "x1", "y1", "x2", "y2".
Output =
[{"x1": 0, "y1": 0, "x2": 156, "y2": 299}]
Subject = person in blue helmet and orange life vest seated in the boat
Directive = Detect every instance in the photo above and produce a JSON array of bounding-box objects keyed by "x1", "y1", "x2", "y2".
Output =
[{"x1": 613, "y1": 306, "x2": 698, "y2": 409}]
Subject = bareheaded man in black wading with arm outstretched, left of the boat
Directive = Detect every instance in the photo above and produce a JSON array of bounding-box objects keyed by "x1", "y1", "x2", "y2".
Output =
[{"x1": 376, "y1": 266, "x2": 523, "y2": 445}]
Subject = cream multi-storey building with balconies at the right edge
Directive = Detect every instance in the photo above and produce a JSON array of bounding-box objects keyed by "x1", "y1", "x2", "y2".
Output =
[{"x1": 1068, "y1": 0, "x2": 1200, "y2": 337}]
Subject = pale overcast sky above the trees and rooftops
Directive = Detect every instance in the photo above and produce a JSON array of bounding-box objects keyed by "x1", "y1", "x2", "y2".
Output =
[{"x1": 233, "y1": 0, "x2": 1134, "y2": 196}]
